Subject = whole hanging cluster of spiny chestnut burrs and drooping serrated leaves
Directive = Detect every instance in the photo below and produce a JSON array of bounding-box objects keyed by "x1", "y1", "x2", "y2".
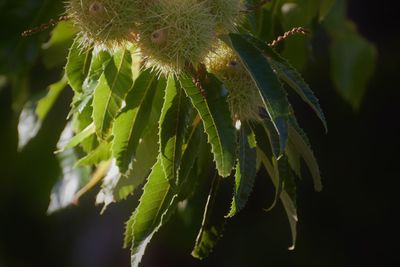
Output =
[{"x1": 21, "y1": 0, "x2": 338, "y2": 266}]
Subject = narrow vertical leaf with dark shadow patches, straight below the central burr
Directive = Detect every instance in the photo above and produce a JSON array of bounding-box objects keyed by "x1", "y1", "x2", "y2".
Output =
[{"x1": 159, "y1": 76, "x2": 189, "y2": 184}]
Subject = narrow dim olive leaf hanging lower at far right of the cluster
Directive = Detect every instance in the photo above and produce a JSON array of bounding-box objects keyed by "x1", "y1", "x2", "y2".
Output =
[{"x1": 289, "y1": 120, "x2": 322, "y2": 191}]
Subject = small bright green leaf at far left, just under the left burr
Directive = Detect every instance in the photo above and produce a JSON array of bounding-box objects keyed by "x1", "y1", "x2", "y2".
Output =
[{"x1": 65, "y1": 36, "x2": 92, "y2": 93}]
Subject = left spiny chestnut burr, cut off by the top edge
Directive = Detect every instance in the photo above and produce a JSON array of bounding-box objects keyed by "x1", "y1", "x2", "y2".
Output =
[{"x1": 66, "y1": 0, "x2": 141, "y2": 47}]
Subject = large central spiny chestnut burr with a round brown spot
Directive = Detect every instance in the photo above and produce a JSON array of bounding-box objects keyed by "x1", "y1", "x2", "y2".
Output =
[{"x1": 138, "y1": 0, "x2": 216, "y2": 74}]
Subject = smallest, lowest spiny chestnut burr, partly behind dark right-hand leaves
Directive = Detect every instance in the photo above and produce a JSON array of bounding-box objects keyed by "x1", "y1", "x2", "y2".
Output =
[{"x1": 206, "y1": 42, "x2": 263, "y2": 121}]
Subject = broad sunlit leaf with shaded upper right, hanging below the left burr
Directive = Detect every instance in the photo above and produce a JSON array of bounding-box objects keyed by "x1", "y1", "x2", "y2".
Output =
[{"x1": 93, "y1": 49, "x2": 133, "y2": 139}]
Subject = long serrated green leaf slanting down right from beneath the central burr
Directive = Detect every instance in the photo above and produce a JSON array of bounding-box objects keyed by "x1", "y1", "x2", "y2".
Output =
[{"x1": 179, "y1": 74, "x2": 236, "y2": 177}]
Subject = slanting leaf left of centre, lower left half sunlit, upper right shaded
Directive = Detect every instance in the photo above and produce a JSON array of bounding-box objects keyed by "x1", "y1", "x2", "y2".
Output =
[{"x1": 112, "y1": 70, "x2": 157, "y2": 174}]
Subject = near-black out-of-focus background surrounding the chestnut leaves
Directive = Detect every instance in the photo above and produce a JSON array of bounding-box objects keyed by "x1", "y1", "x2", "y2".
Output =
[{"x1": 0, "y1": 0, "x2": 400, "y2": 267}]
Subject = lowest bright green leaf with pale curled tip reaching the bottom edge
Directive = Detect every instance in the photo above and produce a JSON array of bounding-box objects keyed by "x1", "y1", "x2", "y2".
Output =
[{"x1": 126, "y1": 159, "x2": 176, "y2": 267}]
